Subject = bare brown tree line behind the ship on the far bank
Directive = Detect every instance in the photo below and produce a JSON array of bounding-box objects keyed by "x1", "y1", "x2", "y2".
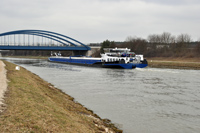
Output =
[{"x1": 97, "y1": 32, "x2": 200, "y2": 58}]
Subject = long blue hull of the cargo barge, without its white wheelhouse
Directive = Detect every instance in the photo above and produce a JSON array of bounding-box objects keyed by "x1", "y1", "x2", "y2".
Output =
[{"x1": 49, "y1": 57, "x2": 148, "y2": 69}]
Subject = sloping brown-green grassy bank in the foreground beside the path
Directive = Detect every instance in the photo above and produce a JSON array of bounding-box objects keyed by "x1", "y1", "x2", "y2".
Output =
[{"x1": 0, "y1": 61, "x2": 122, "y2": 133}]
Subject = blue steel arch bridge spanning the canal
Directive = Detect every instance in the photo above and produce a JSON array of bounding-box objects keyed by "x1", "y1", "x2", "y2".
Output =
[{"x1": 0, "y1": 30, "x2": 91, "y2": 53}]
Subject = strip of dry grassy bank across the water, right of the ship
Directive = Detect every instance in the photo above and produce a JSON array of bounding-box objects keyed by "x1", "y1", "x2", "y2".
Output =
[{"x1": 147, "y1": 57, "x2": 200, "y2": 70}]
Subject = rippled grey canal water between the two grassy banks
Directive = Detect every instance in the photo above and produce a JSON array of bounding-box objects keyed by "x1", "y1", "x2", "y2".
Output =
[{"x1": 1, "y1": 58, "x2": 200, "y2": 133}]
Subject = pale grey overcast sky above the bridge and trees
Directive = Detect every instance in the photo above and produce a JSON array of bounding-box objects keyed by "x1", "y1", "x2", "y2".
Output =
[{"x1": 0, "y1": 0, "x2": 200, "y2": 43}]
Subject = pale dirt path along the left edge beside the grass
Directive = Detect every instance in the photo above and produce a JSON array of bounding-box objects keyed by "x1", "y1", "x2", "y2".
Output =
[{"x1": 0, "y1": 60, "x2": 7, "y2": 112}]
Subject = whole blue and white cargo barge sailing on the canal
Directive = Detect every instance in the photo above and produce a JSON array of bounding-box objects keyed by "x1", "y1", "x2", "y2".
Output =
[{"x1": 48, "y1": 48, "x2": 148, "y2": 69}]
